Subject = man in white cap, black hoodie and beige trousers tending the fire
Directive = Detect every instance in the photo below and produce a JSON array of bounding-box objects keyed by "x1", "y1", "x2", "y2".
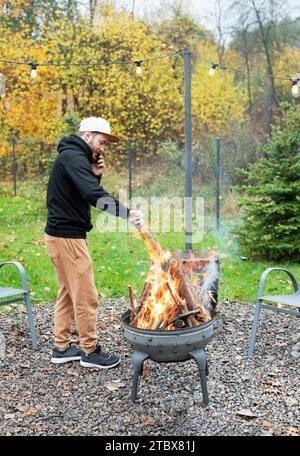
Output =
[{"x1": 45, "y1": 117, "x2": 142, "y2": 369}]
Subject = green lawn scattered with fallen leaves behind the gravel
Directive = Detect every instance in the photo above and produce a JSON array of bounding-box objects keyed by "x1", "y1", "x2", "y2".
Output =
[{"x1": 0, "y1": 179, "x2": 300, "y2": 302}]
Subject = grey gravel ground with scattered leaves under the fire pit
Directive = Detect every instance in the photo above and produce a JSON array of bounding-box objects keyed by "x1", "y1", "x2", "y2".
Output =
[{"x1": 0, "y1": 298, "x2": 300, "y2": 436}]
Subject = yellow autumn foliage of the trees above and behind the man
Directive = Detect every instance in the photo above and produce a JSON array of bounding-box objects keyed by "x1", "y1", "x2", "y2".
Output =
[{"x1": 0, "y1": 0, "x2": 245, "y2": 171}]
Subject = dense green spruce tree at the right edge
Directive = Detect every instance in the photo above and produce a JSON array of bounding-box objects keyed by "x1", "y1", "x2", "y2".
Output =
[{"x1": 236, "y1": 104, "x2": 300, "y2": 261}]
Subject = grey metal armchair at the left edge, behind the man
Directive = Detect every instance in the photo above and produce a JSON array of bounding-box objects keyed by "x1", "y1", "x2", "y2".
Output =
[{"x1": 0, "y1": 261, "x2": 37, "y2": 348}]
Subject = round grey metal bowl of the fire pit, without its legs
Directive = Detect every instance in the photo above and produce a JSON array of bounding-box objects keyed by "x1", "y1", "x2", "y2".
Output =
[{"x1": 122, "y1": 310, "x2": 218, "y2": 363}]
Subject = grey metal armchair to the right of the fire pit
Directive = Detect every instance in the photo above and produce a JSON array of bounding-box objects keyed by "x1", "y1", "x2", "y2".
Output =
[{"x1": 247, "y1": 268, "x2": 300, "y2": 358}]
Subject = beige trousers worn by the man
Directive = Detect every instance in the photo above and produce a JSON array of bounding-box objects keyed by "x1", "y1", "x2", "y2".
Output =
[{"x1": 45, "y1": 234, "x2": 99, "y2": 353}]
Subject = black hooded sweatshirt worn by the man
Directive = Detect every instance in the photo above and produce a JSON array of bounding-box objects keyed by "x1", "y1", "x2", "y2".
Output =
[{"x1": 45, "y1": 135, "x2": 130, "y2": 239}]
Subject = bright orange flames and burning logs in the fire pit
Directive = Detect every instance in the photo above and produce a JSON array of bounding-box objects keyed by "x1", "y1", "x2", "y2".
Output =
[{"x1": 131, "y1": 227, "x2": 218, "y2": 330}]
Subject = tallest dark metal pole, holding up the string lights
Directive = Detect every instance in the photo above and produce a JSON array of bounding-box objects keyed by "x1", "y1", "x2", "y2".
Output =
[{"x1": 183, "y1": 51, "x2": 193, "y2": 250}]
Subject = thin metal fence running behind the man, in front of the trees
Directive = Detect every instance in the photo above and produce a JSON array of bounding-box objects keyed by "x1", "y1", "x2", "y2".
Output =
[{"x1": 0, "y1": 138, "x2": 249, "y2": 235}]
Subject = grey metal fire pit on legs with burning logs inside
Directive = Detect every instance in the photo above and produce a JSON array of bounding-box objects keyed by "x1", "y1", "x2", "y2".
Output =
[{"x1": 122, "y1": 252, "x2": 219, "y2": 405}]
